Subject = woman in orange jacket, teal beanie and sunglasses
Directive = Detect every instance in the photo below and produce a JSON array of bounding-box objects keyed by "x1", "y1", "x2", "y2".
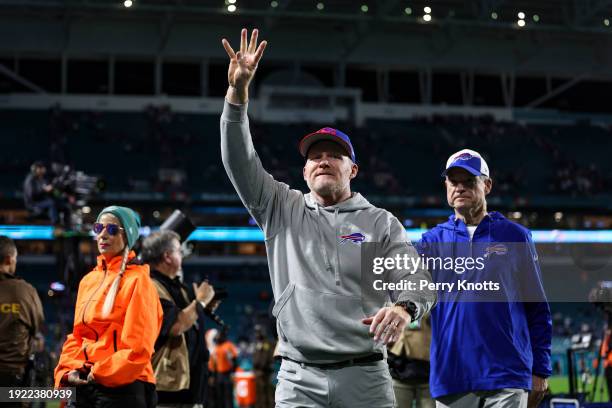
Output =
[{"x1": 55, "y1": 206, "x2": 162, "y2": 408}]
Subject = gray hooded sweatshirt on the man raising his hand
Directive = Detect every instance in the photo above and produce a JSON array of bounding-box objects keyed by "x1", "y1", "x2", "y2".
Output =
[{"x1": 221, "y1": 101, "x2": 436, "y2": 363}]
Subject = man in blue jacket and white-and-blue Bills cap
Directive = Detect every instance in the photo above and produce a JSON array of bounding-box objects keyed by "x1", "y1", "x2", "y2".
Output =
[{"x1": 417, "y1": 149, "x2": 552, "y2": 408}]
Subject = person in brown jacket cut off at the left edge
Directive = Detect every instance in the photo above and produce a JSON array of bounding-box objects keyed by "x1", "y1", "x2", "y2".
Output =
[{"x1": 0, "y1": 236, "x2": 44, "y2": 387}]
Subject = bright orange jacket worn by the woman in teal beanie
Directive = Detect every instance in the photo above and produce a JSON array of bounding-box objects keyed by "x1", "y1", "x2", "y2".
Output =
[{"x1": 55, "y1": 252, "x2": 162, "y2": 387}]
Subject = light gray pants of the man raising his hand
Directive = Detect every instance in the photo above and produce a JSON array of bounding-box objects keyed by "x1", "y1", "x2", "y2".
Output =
[{"x1": 275, "y1": 360, "x2": 395, "y2": 408}]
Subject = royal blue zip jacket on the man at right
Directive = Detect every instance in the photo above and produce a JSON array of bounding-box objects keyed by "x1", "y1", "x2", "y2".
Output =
[{"x1": 417, "y1": 212, "x2": 552, "y2": 398}]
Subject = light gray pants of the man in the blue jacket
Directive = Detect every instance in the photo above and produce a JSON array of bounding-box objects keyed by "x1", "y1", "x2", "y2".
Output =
[{"x1": 436, "y1": 388, "x2": 528, "y2": 408}]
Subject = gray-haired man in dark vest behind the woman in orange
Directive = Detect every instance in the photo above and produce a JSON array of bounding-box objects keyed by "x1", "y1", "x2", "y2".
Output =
[{"x1": 142, "y1": 230, "x2": 218, "y2": 407}]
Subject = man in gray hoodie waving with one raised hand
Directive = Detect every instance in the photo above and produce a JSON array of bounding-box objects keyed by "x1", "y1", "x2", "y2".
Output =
[{"x1": 221, "y1": 29, "x2": 435, "y2": 408}]
